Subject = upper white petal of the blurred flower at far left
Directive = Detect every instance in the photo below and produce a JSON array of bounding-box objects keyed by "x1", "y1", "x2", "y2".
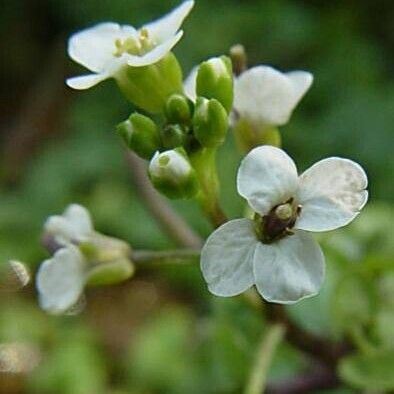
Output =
[{"x1": 44, "y1": 204, "x2": 94, "y2": 245}]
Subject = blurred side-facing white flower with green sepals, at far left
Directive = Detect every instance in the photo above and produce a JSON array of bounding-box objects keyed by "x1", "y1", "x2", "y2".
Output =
[{"x1": 36, "y1": 204, "x2": 133, "y2": 314}]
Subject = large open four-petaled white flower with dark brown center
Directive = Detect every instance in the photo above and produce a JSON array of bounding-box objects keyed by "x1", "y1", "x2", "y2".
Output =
[{"x1": 201, "y1": 146, "x2": 368, "y2": 304}]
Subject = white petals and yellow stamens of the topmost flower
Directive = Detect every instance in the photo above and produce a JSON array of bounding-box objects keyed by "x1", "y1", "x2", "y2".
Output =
[{"x1": 67, "y1": 0, "x2": 194, "y2": 89}]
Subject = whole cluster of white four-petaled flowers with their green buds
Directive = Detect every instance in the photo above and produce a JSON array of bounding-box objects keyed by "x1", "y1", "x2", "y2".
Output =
[{"x1": 30, "y1": 1, "x2": 368, "y2": 313}]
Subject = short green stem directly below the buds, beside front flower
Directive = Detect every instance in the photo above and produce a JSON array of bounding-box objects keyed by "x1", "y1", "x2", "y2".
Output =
[{"x1": 190, "y1": 148, "x2": 227, "y2": 227}]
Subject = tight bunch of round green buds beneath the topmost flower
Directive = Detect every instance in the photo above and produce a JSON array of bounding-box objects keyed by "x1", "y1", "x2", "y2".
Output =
[{"x1": 117, "y1": 56, "x2": 233, "y2": 198}]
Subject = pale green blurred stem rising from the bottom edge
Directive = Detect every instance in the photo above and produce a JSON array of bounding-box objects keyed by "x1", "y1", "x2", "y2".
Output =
[{"x1": 244, "y1": 324, "x2": 285, "y2": 394}]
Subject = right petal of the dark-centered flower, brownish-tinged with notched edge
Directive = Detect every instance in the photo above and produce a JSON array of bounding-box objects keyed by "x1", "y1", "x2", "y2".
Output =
[{"x1": 296, "y1": 157, "x2": 368, "y2": 231}]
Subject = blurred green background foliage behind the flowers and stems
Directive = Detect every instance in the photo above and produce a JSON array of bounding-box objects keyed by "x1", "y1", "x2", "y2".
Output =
[{"x1": 0, "y1": 0, "x2": 394, "y2": 394}]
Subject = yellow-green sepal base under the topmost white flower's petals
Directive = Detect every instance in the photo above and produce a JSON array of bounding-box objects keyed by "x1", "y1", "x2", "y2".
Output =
[{"x1": 114, "y1": 52, "x2": 183, "y2": 113}]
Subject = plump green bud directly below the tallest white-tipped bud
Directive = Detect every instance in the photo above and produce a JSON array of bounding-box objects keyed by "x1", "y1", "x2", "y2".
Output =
[{"x1": 193, "y1": 97, "x2": 228, "y2": 148}]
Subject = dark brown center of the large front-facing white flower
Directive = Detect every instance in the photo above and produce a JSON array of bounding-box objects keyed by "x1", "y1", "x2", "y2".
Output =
[{"x1": 255, "y1": 198, "x2": 302, "y2": 244}]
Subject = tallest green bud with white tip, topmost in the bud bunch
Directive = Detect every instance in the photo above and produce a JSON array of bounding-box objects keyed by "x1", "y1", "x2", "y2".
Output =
[{"x1": 196, "y1": 56, "x2": 233, "y2": 113}]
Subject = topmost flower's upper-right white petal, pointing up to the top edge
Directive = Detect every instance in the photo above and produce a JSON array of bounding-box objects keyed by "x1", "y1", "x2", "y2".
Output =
[{"x1": 144, "y1": 1, "x2": 194, "y2": 43}]
